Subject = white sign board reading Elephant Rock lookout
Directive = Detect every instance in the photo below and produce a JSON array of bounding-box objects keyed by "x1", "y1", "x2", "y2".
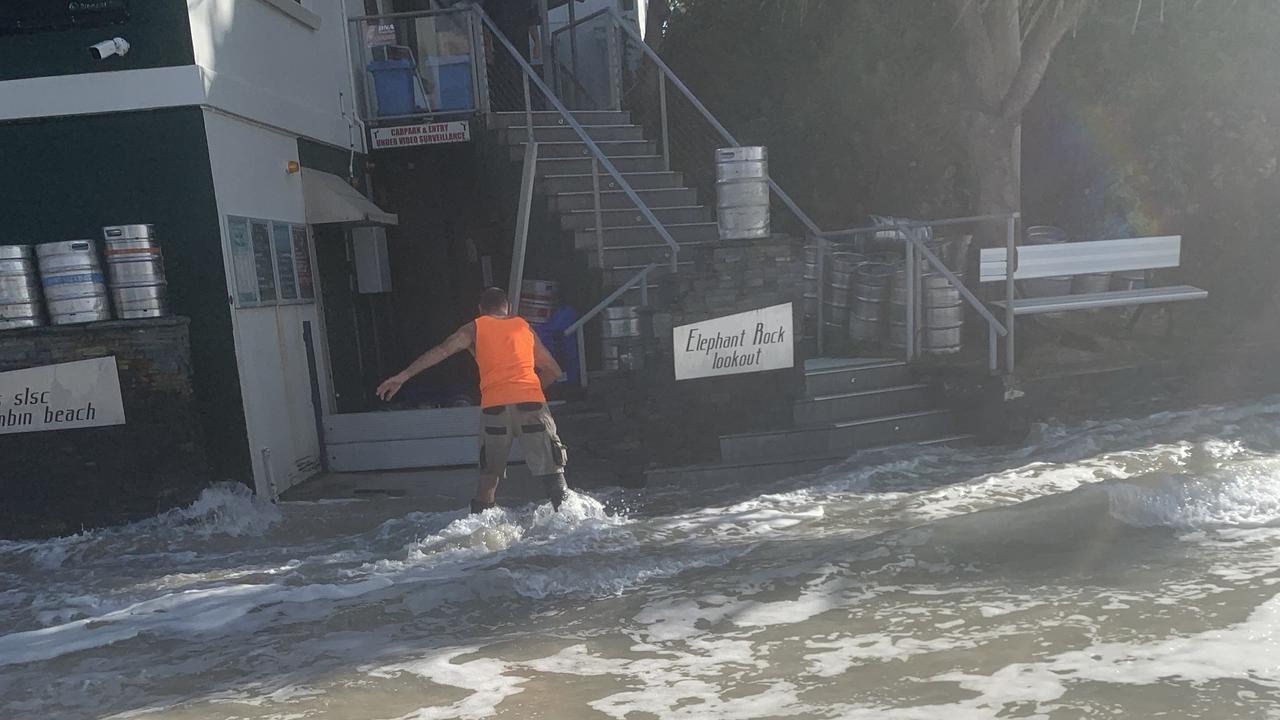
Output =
[{"x1": 672, "y1": 302, "x2": 795, "y2": 380}]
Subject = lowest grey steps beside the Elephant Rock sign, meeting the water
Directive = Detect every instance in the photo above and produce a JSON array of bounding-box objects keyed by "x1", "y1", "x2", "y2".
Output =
[{"x1": 648, "y1": 359, "x2": 970, "y2": 484}]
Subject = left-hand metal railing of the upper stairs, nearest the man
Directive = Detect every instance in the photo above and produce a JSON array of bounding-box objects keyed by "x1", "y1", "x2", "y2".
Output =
[{"x1": 472, "y1": 5, "x2": 680, "y2": 387}]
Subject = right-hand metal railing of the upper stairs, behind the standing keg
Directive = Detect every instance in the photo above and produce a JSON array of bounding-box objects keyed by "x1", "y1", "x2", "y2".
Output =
[{"x1": 550, "y1": 8, "x2": 822, "y2": 236}]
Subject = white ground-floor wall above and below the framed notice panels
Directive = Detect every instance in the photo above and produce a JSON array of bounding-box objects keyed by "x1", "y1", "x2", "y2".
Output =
[{"x1": 205, "y1": 109, "x2": 330, "y2": 497}]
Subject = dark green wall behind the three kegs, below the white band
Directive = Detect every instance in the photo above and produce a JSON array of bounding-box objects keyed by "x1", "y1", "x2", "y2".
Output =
[{"x1": 0, "y1": 108, "x2": 251, "y2": 479}]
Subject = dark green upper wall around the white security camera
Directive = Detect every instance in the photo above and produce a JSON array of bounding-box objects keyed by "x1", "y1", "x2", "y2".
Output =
[{"x1": 0, "y1": 0, "x2": 196, "y2": 81}]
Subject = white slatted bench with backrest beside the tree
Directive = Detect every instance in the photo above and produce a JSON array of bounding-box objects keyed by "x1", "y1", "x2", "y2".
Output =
[{"x1": 978, "y1": 236, "x2": 1208, "y2": 315}]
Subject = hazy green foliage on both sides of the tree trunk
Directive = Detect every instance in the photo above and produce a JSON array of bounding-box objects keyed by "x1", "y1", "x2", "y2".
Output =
[{"x1": 663, "y1": 0, "x2": 1280, "y2": 318}]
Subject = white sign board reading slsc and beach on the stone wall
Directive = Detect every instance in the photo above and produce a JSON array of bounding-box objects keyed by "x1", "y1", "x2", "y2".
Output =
[{"x1": 0, "y1": 357, "x2": 124, "y2": 434}]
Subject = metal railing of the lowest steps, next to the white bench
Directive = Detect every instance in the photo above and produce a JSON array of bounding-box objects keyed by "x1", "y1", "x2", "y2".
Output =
[{"x1": 814, "y1": 213, "x2": 1021, "y2": 373}]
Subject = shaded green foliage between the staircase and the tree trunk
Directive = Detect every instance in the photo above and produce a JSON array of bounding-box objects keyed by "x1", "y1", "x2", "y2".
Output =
[{"x1": 663, "y1": 0, "x2": 966, "y2": 227}]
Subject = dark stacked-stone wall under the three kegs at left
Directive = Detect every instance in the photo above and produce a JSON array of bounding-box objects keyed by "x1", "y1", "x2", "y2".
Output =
[{"x1": 0, "y1": 318, "x2": 212, "y2": 538}]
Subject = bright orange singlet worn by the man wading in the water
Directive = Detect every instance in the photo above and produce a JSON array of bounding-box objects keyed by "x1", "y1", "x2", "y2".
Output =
[{"x1": 476, "y1": 315, "x2": 547, "y2": 407}]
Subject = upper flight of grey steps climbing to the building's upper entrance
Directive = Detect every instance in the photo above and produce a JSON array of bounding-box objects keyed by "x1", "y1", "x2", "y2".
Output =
[{"x1": 490, "y1": 110, "x2": 717, "y2": 304}]
